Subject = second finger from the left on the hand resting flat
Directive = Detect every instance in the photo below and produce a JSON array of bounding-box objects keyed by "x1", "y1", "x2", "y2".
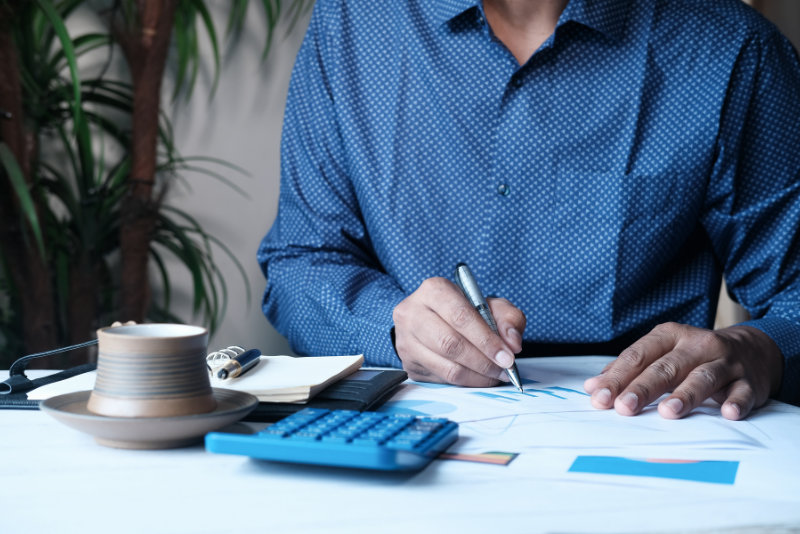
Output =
[{"x1": 614, "y1": 348, "x2": 704, "y2": 415}]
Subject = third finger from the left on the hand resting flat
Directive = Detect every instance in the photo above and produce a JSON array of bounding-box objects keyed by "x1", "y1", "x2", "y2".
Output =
[{"x1": 658, "y1": 360, "x2": 736, "y2": 419}]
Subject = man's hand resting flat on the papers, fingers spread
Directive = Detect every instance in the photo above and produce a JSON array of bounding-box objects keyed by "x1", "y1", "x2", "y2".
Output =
[{"x1": 584, "y1": 323, "x2": 783, "y2": 420}]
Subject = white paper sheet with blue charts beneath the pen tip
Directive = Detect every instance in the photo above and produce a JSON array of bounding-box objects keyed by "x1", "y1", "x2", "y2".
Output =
[{"x1": 380, "y1": 359, "x2": 768, "y2": 454}]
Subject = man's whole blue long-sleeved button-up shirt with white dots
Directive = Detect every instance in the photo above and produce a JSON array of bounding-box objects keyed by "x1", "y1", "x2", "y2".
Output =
[{"x1": 258, "y1": 0, "x2": 800, "y2": 402}]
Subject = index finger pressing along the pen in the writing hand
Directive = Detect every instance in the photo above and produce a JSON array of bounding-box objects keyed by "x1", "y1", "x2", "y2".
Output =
[{"x1": 423, "y1": 278, "x2": 514, "y2": 369}]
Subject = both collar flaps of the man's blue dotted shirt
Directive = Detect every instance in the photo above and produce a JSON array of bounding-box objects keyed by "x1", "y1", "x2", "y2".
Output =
[{"x1": 436, "y1": 0, "x2": 630, "y2": 40}]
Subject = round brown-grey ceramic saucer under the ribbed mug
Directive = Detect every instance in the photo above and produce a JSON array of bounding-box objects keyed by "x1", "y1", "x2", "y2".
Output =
[{"x1": 39, "y1": 388, "x2": 258, "y2": 449}]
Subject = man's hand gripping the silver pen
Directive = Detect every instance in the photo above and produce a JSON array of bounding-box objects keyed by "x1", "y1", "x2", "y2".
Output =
[{"x1": 393, "y1": 278, "x2": 526, "y2": 387}]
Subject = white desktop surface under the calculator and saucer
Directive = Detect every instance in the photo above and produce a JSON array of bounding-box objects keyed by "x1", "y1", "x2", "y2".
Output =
[{"x1": 0, "y1": 357, "x2": 800, "y2": 534}]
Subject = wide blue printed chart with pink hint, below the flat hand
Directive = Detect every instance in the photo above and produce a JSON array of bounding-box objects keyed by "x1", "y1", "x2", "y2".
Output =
[{"x1": 569, "y1": 456, "x2": 739, "y2": 484}]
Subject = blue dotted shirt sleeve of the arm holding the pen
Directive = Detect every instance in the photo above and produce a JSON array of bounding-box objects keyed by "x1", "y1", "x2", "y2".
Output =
[{"x1": 258, "y1": 1, "x2": 406, "y2": 366}]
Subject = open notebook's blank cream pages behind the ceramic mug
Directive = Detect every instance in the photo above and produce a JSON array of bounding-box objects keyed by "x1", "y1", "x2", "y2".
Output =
[{"x1": 28, "y1": 354, "x2": 364, "y2": 403}]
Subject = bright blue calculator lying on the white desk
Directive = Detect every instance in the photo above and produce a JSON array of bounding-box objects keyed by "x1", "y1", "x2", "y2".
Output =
[{"x1": 206, "y1": 408, "x2": 458, "y2": 471}]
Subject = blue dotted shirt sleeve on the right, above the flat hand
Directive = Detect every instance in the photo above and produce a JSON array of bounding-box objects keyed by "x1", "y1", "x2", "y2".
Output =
[{"x1": 702, "y1": 31, "x2": 800, "y2": 404}]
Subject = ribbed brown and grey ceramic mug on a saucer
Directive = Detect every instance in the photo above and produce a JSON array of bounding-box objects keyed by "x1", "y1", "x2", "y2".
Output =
[{"x1": 87, "y1": 324, "x2": 217, "y2": 417}]
